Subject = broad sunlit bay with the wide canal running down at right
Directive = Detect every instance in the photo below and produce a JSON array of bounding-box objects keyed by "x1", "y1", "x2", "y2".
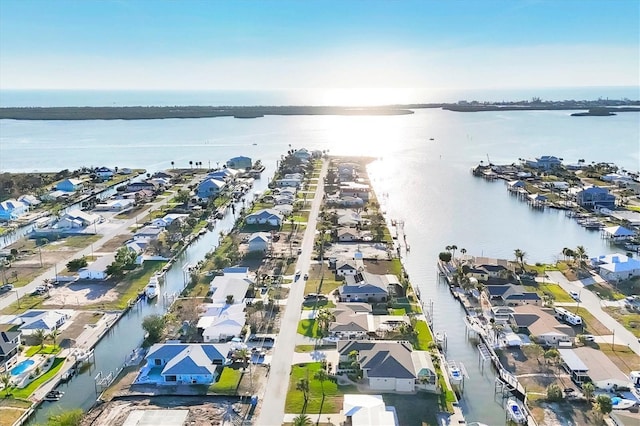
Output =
[{"x1": 0, "y1": 89, "x2": 640, "y2": 424}]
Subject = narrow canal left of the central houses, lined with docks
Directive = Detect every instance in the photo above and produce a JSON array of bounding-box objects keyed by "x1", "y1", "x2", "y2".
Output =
[{"x1": 29, "y1": 176, "x2": 271, "y2": 424}]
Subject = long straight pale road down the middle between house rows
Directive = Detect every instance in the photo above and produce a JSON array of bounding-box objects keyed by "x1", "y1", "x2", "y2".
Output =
[{"x1": 257, "y1": 161, "x2": 329, "y2": 426}]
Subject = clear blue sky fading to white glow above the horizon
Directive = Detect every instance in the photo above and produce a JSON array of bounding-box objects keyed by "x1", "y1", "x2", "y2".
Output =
[{"x1": 0, "y1": 0, "x2": 640, "y2": 90}]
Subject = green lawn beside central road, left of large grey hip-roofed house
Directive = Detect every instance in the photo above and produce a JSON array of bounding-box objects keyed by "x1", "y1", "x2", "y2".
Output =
[{"x1": 285, "y1": 362, "x2": 344, "y2": 414}]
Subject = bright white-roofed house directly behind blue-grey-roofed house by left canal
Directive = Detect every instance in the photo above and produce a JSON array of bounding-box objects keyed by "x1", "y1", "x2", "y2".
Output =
[{"x1": 196, "y1": 303, "x2": 247, "y2": 342}]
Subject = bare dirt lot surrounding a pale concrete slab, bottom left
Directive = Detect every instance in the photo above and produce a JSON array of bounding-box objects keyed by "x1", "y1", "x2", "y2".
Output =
[{"x1": 81, "y1": 396, "x2": 250, "y2": 426}]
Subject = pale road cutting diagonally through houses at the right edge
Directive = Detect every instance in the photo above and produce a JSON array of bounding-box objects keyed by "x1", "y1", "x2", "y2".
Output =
[{"x1": 547, "y1": 271, "x2": 640, "y2": 355}]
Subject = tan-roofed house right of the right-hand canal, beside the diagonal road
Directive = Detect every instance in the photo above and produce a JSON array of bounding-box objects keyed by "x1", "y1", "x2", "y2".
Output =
[{"x1": 509, "y1": 305, "x2": 576, "y2": 346}]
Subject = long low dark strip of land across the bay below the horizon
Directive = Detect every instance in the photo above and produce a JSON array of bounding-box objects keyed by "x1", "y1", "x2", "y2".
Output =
[{"x1": 0, "y1": 101, "x2": 640, "y2": 120}]
